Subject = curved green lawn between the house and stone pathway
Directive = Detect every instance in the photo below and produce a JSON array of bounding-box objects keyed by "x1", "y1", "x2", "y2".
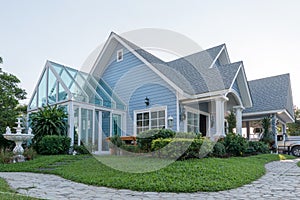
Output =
[{"x1": 0, "y1": 154, "x2": 294, "y2": 192}]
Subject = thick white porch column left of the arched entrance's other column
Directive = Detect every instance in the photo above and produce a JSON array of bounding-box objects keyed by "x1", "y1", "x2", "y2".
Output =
[{"x1": 215, "y1": 96, "x2": 228, "y2": 137}]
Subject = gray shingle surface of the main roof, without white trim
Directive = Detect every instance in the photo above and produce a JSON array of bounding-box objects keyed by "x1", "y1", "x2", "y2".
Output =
[{"x1": 119, "y1": 36, "x2": 241, "y2": 94}]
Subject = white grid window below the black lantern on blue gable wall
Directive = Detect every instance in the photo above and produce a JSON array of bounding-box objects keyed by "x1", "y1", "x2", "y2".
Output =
[{"x1": 136, "y1": 110, "x2": 166, "y2": 134}]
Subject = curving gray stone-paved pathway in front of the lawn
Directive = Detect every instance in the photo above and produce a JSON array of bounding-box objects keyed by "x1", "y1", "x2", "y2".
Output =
[{"x1": 0, "y1": 159, "x2": 300, "y2": 200}]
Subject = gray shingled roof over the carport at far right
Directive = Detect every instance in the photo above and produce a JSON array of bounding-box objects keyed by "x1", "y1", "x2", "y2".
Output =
[{"x1": 243, "y1": 74, "x2": 294, "y2": 116}]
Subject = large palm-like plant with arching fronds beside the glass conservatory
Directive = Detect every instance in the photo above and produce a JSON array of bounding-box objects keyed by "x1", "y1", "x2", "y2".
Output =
[{"x1": 30, "y1": 105, "x2": 68, "y2": 142}]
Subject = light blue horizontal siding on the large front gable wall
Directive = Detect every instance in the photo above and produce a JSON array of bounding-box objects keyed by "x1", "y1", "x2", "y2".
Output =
[{"x1": 101, "y1": 42, "x2": 177, "y2": 135}]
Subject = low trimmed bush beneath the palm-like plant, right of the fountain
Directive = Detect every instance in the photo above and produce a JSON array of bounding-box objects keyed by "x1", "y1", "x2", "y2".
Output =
[{"x1": 36, "y1": 135, "x2": 71, "y2": 155}]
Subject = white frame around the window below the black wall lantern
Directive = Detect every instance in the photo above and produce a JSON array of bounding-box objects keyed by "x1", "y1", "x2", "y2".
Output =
[{"x1": 133, "y1": 106, "x2": 168, "y2": 136}]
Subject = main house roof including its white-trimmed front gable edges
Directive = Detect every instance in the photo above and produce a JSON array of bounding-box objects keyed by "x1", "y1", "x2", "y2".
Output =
[{"x1": 92, "y1": 33, "x2": 248, "y2": 98}]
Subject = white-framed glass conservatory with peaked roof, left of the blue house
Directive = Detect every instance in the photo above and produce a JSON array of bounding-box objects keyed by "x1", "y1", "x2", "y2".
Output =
[{"x1": 28, "y1": 61, "x2": 127, "y2": 153}]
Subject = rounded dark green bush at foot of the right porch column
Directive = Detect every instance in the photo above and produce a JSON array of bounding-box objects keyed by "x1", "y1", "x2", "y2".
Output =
[{"x1": 223, "y1": 133, "x2": 248, "y2": 156}]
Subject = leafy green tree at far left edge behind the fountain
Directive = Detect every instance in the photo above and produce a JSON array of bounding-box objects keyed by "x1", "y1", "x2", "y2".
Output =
[{"x1": 0, "y1": 72, "x2": 26, "y2": 133}]
